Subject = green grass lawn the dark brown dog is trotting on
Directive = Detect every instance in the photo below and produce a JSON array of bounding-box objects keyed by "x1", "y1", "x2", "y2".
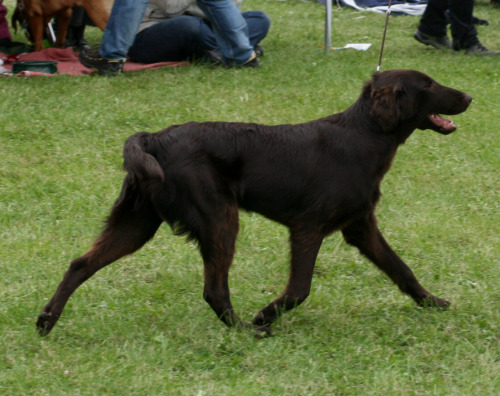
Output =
[{"x1": 0, "y1": 0, "x2": 500, "y2": 396}]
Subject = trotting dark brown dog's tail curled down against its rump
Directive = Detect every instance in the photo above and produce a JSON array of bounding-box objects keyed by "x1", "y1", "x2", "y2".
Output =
[{"x1": 123, "y1": 132, "x2": 165, "y2": 182}]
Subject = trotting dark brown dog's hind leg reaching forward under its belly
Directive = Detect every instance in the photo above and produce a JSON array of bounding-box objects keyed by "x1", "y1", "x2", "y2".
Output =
[{"x1": 201, "y1": 204, "x2": 242, "y2": 327}]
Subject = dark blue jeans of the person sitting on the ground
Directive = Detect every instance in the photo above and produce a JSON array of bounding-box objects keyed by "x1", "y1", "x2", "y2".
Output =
[{"x1": 129, "y1": 11, "x2": 271, "y2": 63}]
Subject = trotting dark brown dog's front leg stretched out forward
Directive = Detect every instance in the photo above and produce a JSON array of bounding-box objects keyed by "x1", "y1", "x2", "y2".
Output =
[{"x1": 342, "y1": 213, "x2": 450, "y2": 308}]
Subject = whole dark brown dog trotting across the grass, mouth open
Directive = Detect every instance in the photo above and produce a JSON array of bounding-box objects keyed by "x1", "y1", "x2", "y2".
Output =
[{"x1": 37, "y1": 70, "x2": 472, "y2": 335}]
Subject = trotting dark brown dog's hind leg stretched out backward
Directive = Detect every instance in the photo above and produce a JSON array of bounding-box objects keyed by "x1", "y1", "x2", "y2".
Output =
[{"x1": 36, "y1": 192, "x2": 162, "y2": 335}]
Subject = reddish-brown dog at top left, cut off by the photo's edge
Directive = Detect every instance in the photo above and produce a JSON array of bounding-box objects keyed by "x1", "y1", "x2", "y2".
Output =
[{"x1": 11, "y1": 0, "x2": 114, "y2": 51}]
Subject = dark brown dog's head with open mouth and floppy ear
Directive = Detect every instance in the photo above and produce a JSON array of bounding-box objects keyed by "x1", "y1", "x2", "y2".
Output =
[{"x1": 365, "y1": 70, "x2": 472, "y2": 135}]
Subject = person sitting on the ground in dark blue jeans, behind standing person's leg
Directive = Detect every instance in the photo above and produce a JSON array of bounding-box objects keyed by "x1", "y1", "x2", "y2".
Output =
[{"x1": 128, "y1": 0, "x2": 270, "y2": 64}]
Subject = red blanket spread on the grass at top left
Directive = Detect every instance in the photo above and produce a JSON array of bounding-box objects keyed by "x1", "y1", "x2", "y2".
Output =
[{"x1": 0, "y1": 47, "x2": 189, "y2": 77}]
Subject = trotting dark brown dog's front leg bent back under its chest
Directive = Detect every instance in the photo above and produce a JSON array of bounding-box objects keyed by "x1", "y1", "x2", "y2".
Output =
[{"x1": 253, "y1": 227, "x2": 324, "y2": 333}]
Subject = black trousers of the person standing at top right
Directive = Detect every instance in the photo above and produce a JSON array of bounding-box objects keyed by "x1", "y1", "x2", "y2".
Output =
[{"x1": 418, "y1": 0, "x2": 479, "y2": 49}]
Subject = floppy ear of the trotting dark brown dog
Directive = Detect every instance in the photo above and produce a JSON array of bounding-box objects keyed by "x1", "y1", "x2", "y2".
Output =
[{"x1": 370, "y1": 84, "x2": 411, "y2": 132}]
